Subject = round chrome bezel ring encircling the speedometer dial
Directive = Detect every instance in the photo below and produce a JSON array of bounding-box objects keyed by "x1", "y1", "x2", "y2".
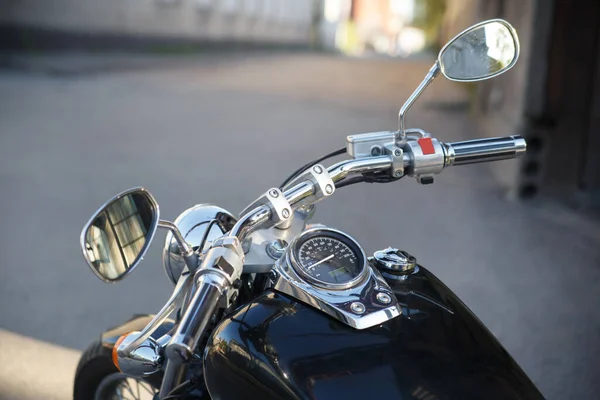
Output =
[{"x1": 286, "y1": 227, "x2": 368, "y2": 290}]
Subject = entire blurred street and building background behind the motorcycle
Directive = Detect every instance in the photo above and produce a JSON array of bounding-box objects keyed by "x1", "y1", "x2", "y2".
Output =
[{"x1": 0, "y1": 0, "x2": 600, "y2": 399}]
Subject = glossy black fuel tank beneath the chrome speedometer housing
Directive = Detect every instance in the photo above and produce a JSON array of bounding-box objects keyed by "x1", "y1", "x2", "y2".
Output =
[{"x1": 204, "y1": 267, "x2": 542, "y2": 400}]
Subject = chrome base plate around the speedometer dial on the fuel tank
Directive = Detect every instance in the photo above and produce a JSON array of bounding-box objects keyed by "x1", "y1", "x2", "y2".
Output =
[{"x1": 271, "y1": 228, "x2": 401, "y2": 329}]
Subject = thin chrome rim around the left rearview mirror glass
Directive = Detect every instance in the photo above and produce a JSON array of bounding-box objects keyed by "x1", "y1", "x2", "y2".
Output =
[{"x1": 79, "y1": 187, "x2": 160, "y2": 283}]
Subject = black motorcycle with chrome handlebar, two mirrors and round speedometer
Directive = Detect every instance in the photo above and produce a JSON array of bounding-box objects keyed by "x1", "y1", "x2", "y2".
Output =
[{"x1": 74, "y1": 19, "x2": 542, "y2": 400}]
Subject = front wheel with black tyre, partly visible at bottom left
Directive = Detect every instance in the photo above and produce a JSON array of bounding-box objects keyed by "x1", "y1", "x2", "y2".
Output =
[{"x1": 73, "y1": 341, "x2": 158, "y2": 400}]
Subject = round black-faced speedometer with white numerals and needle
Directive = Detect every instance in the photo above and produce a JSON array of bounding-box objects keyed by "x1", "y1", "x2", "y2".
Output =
[{"x1": 292, "y1": 228, "x2": 366, "y2": 289}]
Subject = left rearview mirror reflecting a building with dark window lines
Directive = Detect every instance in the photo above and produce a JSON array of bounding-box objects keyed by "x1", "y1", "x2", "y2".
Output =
[{"x1": 80, "y1": 188, "x2": 159, "y2": 282}]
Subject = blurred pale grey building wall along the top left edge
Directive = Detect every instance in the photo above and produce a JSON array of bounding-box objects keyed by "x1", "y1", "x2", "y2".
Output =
[{"x1": 0, "y1": 0, "x2": 320, "y2": 43}]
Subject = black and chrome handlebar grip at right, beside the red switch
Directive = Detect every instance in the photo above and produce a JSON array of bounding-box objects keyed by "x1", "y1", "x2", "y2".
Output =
[{"x1": 446, "y1": 136, "x2": 527, "y2": 166}]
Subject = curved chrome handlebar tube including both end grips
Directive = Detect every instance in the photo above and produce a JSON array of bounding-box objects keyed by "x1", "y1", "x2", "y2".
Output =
[{"x1": 166, "y1": 136, "x2": 526, "y2": 374}]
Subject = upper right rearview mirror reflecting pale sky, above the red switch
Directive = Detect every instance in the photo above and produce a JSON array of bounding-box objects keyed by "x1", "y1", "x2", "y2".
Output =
[{"x1": 438, "y1": 19, "x2": 519, "y2": 82}]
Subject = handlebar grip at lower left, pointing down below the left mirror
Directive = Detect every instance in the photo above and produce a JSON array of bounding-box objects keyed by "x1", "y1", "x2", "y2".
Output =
[{"x1": 165, "y1": 273, "x2": 226, "y2": 364}]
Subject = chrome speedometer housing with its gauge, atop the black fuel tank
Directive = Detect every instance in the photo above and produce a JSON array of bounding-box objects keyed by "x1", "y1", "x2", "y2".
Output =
[{"x1": 269, "y1": 226, "x2": 401, "y2": 329}]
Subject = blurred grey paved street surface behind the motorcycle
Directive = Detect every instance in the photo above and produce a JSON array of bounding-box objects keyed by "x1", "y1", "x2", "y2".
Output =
[{"x1": 0, "y1": 54, "x2": 600, "y2": 399}]
